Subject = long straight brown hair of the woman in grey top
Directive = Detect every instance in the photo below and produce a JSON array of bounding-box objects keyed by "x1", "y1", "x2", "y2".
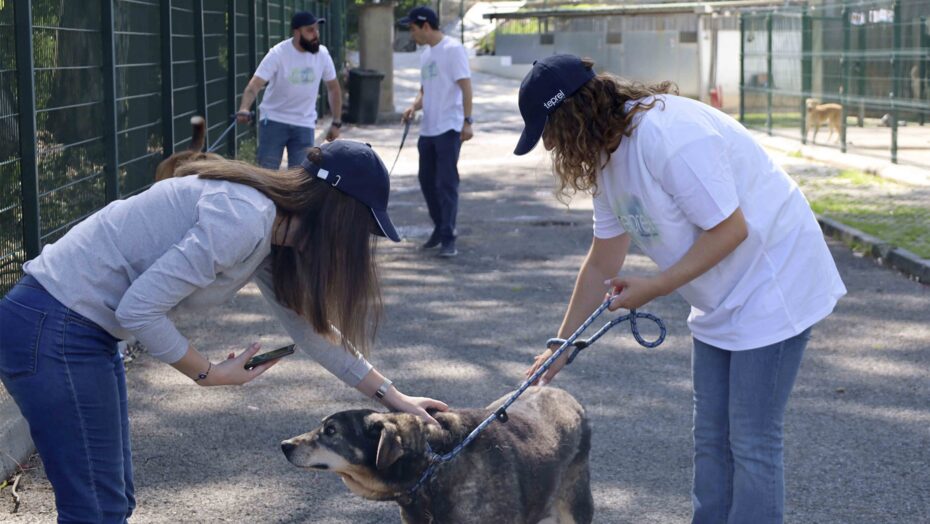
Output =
[{"x1": 175, "y1": 148, "x2": 382, "y2": 357}]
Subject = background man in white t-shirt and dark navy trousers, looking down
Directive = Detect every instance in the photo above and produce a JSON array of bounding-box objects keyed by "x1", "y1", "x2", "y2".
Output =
[{"x1": 398, "y1": 7, "x2": 473, "y2": 257}]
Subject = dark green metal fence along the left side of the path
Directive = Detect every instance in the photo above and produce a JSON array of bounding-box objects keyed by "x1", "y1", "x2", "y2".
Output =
[{"x1": 0, "y1": 0, "x2": 345, "y2": 294}]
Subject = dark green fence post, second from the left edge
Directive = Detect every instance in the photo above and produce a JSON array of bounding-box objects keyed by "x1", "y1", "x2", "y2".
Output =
[{"x1": 100, "y1": 0, "x2": 120, "y2": 202}]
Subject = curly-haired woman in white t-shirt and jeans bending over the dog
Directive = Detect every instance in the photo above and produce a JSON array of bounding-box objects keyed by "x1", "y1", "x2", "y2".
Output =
[{"x1": 515, "y1": 55, "x2": 846, "y2": 523}]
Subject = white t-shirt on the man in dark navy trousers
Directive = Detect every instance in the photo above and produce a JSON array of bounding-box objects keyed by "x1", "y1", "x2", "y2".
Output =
[{"x1": 420, "y1": 36, "x2": 471, "y2": 136}]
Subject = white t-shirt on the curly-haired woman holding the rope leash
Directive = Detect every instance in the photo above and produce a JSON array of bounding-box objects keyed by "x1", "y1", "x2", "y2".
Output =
[{"x1": 594, "y1": 95, "x2": 846, "y2": 351}]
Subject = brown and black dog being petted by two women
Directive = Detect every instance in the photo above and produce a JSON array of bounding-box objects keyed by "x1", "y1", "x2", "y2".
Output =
[{"x1": 281, "y1": 387, "x2": 594, "y2": 524}]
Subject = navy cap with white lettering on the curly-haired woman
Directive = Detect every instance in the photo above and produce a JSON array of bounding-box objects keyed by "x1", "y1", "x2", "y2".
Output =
[{"x1": 513, "y1": 55, "x2": 597, "y2": 155}]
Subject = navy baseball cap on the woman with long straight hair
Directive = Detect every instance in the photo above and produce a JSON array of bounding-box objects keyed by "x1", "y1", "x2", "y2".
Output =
[{"x1": 301, "y1": 140, "x2": 400, "y2": 242}]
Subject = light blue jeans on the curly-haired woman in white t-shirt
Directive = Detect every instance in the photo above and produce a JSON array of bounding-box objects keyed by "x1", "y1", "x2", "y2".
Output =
[{"x1": 691, "y1": 328, "x2": 811, "y2": 524}]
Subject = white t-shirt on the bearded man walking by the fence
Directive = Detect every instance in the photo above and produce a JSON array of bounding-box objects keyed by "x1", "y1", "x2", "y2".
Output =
[{"x1": 255, "y1": 38, "x2": 336, "y2": 127}]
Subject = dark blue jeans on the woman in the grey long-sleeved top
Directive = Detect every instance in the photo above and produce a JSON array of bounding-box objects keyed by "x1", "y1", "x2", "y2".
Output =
[{"x1": 0, "y1": 275, "x2": 136, "y2": 523}]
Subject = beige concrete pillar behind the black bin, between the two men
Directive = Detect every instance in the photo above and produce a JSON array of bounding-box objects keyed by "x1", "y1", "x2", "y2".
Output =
[{"x1": 358, "y1": 2, "x2": 394, "y2": 117}]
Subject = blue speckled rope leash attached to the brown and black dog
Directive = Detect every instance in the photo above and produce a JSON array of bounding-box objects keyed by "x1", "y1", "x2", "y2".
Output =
[{"x1": 406, "y1": 295, "x2": 667, "y2": 497}]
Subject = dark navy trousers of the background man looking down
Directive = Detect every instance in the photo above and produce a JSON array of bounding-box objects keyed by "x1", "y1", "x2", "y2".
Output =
[{"x1": 417, "y1": 130, "x2": 462, "y2": 244}]
